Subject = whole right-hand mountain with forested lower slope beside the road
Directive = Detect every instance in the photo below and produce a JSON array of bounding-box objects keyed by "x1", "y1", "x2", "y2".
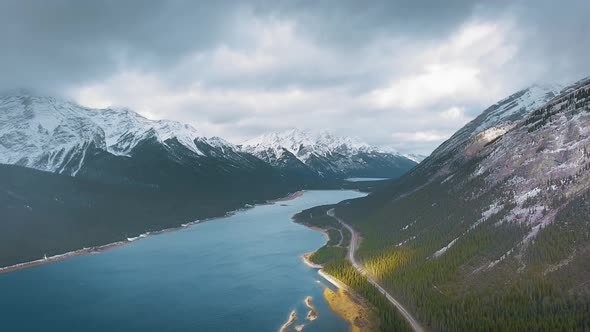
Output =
[{"x1": 336, "y1": 79, "x2": 590, "y2": 330}]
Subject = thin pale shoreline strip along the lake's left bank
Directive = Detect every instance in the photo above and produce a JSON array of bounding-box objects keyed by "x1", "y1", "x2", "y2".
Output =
[{"x1": 0, "y1": 190, "x2": 305, "y2": 274}]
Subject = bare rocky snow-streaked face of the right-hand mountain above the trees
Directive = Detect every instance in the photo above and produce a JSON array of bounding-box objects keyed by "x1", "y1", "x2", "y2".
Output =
[{"x1": 424, "y1": 78, "x2": 590, "y2": 233}]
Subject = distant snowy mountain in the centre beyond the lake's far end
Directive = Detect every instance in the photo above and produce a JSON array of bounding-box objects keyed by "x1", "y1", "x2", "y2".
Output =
[{"x1": 241, "y1": 129, "x2": 416, "y2": 178}]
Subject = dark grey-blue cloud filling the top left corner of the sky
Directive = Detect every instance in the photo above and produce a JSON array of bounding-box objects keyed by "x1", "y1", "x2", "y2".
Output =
[{"x1": 0, "y1": 0, "x2": 246, "y2": 93}]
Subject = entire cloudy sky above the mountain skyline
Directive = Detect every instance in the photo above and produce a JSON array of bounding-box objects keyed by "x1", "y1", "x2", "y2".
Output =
[{"x1": 0, "y1": 0, "x2": 590, "y2": 154}]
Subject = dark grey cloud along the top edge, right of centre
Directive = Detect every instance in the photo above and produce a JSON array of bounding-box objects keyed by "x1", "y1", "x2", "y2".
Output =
[{"x1": 255, "y1": 0, "x2": 508, "y2": 48}]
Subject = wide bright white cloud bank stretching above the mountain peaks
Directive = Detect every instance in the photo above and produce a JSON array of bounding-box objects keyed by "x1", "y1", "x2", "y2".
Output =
[{"x1": 71, "y1": 16, "x2": 544, "y2": 153}]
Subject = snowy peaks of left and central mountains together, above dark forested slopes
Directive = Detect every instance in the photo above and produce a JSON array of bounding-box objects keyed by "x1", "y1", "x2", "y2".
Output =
[{"x1": 0, "y1": 94, "x2": 416, "y2": 180}]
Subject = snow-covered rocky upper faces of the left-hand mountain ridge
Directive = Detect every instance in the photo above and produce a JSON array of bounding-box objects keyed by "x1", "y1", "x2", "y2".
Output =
[{"x1": 0, "y1": 95, "x2": 247, "y2": 175}]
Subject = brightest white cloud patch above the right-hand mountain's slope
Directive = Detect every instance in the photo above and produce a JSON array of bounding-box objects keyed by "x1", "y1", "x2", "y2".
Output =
[{"x1": 367, "y1": 22, "x2": 516, "y2": 109}]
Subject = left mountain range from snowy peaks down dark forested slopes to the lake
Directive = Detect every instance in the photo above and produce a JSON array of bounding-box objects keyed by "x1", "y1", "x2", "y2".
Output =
[{"x1": 0, "y1": 92, "x2": 416, "y2": 266}]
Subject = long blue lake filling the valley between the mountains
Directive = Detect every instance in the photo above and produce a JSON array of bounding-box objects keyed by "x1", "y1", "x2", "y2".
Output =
[{"x1": 0, "y1": 191, "x2": 364, "y2": 332}]
